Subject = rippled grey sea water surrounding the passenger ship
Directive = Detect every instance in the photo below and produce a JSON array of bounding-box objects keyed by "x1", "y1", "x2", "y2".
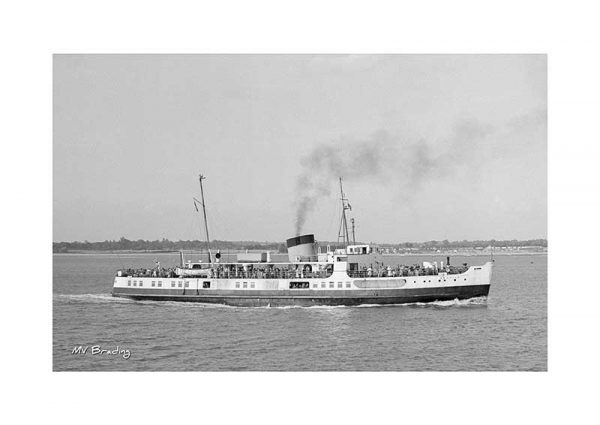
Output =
[{"x1": 53, "y1": 254, "x2": 547, "y2": 371}]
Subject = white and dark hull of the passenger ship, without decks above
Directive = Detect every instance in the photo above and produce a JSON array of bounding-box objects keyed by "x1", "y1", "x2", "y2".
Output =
[{"x1": 113, "y1": 262, "x2": 493, "y2": 306}]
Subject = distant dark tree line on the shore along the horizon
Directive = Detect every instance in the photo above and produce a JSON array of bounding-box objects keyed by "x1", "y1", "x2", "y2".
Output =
[{"x1": 52, "y1": 237, "x2": 548, "y2": 253}]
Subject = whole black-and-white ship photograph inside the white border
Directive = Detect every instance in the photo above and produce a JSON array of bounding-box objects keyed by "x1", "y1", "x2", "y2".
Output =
[{"x1": 53, "y1": 54, "x2": 548, "y2": 371}]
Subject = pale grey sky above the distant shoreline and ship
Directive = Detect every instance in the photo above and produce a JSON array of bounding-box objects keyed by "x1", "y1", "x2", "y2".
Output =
[{"x1": 53, "y1": 54, "x2": 547, "y2": 242}]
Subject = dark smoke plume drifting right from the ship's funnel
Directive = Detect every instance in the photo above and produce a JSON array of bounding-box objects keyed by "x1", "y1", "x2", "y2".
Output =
[{"x1": 295, "y1": 122, "x2": 494, "y2": 234}]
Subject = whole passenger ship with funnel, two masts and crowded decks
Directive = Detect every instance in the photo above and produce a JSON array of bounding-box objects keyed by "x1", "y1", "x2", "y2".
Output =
[{"x1": 112, "y1": 175, "x2": 494, "y2": 307}]
